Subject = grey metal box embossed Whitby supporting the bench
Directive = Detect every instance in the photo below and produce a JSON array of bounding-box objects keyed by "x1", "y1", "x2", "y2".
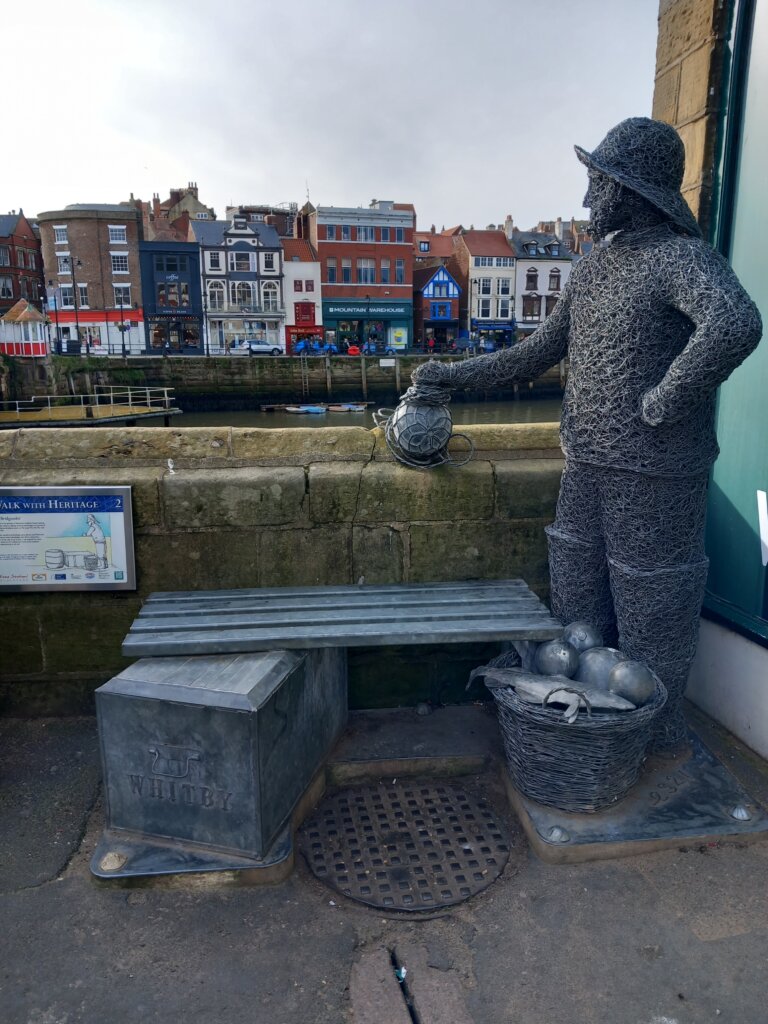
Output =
[{"x1": 96, "y1": 648, "x2": 347, "y2": 873}]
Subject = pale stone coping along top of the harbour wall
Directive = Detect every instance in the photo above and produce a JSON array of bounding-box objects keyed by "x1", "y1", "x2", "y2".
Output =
[{"x1": 0, "y1": 423, "x2": 560, "y2": 466}]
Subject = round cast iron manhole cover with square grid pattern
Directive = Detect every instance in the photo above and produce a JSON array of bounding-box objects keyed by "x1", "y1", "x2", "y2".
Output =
[{"x1": 299, "y1": 782, "x2": 509, "y2": 910}]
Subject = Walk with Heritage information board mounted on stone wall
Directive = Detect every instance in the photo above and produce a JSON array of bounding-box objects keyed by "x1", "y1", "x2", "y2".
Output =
[{"x1": 0, "y1": 486, "x2": 136, "y2": 591}]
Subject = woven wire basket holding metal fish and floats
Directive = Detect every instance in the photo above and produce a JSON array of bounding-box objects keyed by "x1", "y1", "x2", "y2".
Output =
[{"x1": 492, "y1": 680, "x2": 667, "y2": 812}]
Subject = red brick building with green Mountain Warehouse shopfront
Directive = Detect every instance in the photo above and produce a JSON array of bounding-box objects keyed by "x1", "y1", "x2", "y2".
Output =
[{"x1": 296, "y1": 200, "x2": 416, "y2": 352}]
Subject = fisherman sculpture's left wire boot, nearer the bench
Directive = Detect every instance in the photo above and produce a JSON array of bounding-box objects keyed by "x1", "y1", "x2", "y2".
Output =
[{"x1": 546, "y1": 524, "x2": 616, "y2": 646}]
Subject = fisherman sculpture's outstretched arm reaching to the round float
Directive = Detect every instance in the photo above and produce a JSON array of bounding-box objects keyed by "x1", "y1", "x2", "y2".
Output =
[{"x1": 412, "y1": 283, "x2": 570, "y2": 391}]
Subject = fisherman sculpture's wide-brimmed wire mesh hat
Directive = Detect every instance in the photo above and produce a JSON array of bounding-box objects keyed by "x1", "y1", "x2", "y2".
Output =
[{"x1": 573, "y1": 118, "x2": 701, "y2": 236}]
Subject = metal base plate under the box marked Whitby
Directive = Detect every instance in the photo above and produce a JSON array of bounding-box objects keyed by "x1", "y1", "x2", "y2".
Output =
[{"x1": 90, "y1": 824, "x2": 293, "y2": 882}]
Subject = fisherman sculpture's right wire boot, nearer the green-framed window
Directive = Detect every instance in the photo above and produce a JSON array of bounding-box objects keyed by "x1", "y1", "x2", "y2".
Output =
[{"x1": 608, "y1": 559, "x2": 709, "y2": 753}]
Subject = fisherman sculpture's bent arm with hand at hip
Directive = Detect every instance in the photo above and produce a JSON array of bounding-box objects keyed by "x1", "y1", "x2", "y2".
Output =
[{"x1": 642, "y1": 243, "x2": 763, "y2": 427}]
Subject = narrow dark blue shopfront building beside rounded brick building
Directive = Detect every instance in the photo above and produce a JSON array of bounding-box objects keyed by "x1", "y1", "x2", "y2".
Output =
[{"x1": 138, "y1": 242, "x2": 203, "y2": 355}]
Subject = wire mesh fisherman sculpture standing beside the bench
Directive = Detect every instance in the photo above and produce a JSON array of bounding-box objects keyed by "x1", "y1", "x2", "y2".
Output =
[{"x1": 411, "y1": 118, "x2": 762, "y2": 751}]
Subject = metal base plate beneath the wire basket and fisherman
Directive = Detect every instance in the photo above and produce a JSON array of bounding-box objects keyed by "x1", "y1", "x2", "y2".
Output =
[{"x1": 504, "y1": 733, "x2": 768, "y2": 863}]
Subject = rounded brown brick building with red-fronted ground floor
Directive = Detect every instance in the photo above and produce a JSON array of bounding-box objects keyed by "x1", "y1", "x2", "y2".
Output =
[{"x1": 37, "y1": 203, "x2": 144, "y2": 355}]
